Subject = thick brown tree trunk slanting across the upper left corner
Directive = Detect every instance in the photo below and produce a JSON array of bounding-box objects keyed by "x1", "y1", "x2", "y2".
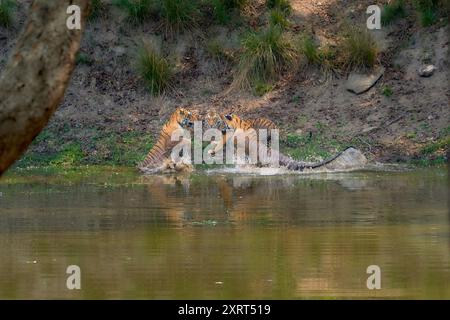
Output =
[{"x1": 0, "y1": 0, "x2": 90, "y2": 175}]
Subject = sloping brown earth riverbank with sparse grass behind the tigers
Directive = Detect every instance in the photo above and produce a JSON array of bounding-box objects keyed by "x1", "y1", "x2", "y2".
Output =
[{"x1": 0, "y1": 0, "x2": 450, "y2": 168}]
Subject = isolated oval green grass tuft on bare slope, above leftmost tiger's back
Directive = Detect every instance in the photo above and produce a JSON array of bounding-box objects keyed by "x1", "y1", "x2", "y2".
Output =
[{"x1": 137, "y1": 45, "x2": 173, "y2": 95}]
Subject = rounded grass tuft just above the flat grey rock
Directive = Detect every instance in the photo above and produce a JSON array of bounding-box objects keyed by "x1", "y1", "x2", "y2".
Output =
[{"x1": 341, "y1": 28, "x2": 378, "y2": 69}]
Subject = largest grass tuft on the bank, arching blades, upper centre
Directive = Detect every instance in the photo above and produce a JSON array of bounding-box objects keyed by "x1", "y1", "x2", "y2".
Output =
[{"x1": 233, "y1": 26, "x2": 297, "y2": 87}]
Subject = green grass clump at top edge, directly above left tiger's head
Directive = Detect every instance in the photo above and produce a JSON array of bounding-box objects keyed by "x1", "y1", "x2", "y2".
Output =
[{"x1": 159, "y1": 0, "x2": 199, "y2": 32}]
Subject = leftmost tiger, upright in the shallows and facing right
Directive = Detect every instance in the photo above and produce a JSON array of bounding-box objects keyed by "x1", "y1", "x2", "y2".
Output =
[{"x1": 138, "y1": 108, "x2": 200, "y2": 173}]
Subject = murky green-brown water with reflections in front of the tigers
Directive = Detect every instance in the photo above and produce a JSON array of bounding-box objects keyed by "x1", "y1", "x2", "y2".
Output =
[{"x1": 0, "y1": 168, "x2": 450, "y2": 299}]
